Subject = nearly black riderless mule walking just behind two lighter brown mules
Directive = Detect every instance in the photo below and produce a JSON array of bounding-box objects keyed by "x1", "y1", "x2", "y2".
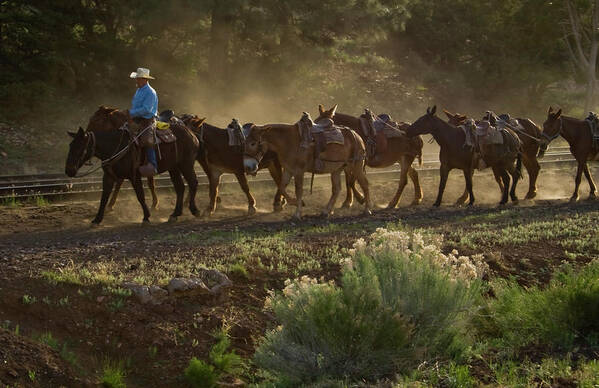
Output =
[{"x1": 406, "y1": 106, "x2": 521, "y2": 207}]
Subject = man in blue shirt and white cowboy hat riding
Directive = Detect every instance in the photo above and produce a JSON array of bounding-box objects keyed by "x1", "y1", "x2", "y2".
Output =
[{"x1": 128, "y1": 67, "x2": 158, "y2": 176}]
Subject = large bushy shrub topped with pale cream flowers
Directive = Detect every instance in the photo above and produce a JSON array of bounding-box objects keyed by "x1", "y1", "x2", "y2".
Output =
[{"x1": 255, "y1": 229, "x2": 482, "y2": 382}]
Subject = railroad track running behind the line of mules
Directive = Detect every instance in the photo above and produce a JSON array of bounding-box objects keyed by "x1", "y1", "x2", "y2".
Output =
[{"x1": 0, "y1": 147, "x2": 575, "y2": 200}]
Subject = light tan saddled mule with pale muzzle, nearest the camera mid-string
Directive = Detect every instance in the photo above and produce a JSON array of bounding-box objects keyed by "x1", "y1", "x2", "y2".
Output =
[{"x1": 245, "y1": 112, "x2": 371, "y2": 220}]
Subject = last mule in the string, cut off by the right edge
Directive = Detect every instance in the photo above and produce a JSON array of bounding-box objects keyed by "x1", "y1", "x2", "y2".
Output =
[{"x1": 543, "y1": 107, "x2": 599, "y2": 202}]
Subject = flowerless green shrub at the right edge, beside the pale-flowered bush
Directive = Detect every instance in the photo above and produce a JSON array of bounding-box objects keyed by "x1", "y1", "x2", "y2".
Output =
[{"x1": 481, "y1": 261, "x2": 599, "y2": 349}]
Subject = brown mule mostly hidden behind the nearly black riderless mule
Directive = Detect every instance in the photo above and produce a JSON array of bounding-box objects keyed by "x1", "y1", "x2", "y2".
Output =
[{"x1": 443, "y1": 110, "x2": 543, "y2": 205}]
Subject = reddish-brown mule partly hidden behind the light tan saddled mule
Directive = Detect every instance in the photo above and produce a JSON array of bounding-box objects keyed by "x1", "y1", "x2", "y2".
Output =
[{"x1": 317, "y1": 105, "x2": 423, "y2": 209}]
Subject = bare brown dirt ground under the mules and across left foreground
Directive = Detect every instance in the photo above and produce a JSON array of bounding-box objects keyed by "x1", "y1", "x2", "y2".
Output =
[{"x1": 0, "y1": 174, "x2": 599, "y2": 387}]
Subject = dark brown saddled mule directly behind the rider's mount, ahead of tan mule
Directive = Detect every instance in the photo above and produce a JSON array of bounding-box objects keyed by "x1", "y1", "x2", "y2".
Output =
[{"x1": 183, "y1": 115, "x2": 283, "y2": 215}]
